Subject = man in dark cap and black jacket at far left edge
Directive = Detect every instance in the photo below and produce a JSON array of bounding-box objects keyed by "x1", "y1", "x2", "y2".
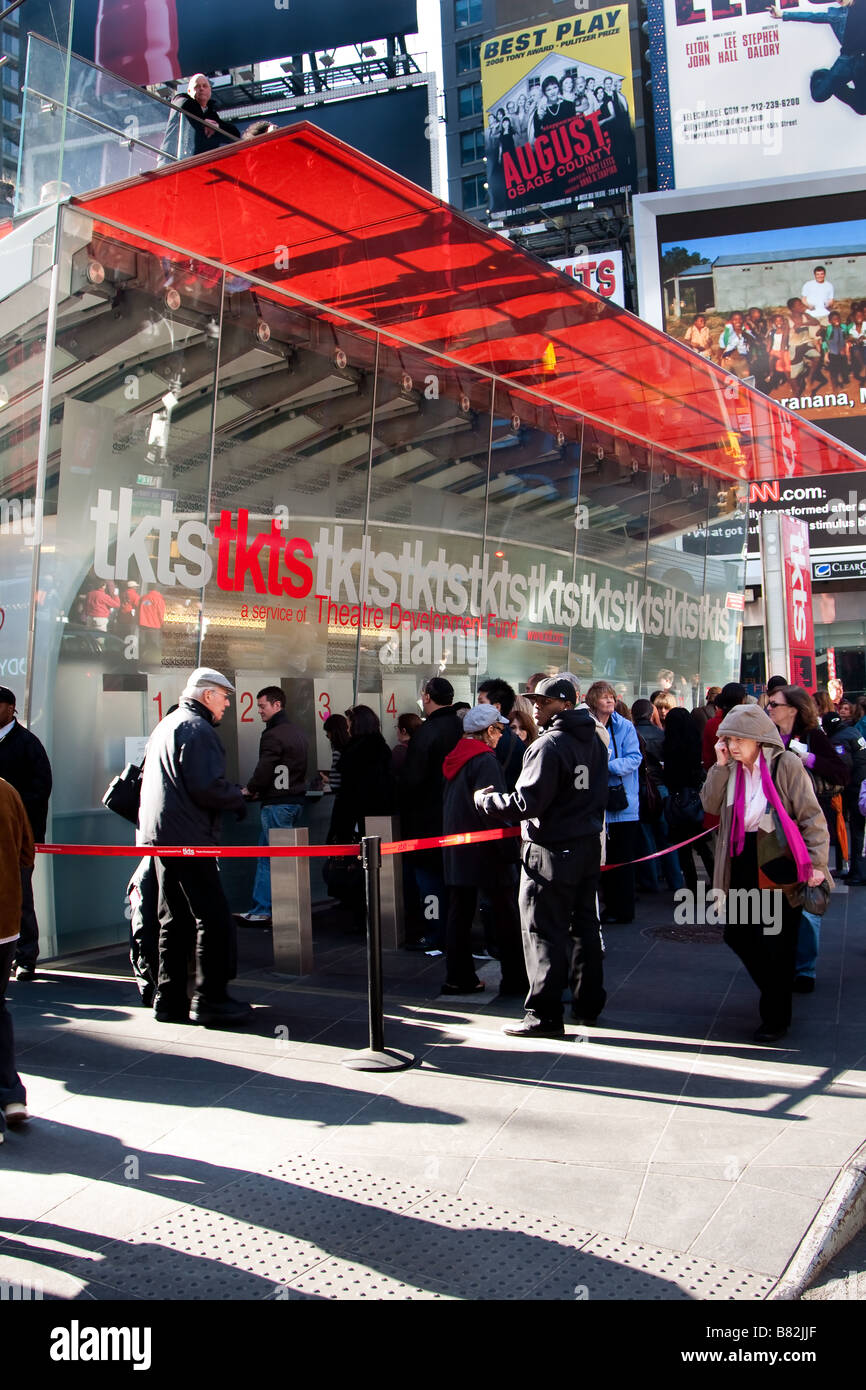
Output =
[{"x1": 0, "y1": 685, "x2": 51, "y2": 983}]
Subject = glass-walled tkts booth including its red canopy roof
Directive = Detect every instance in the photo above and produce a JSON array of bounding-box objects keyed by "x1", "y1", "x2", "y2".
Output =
[{"x1": 0, "y1": 125, "x2": 862, "y2": 954}]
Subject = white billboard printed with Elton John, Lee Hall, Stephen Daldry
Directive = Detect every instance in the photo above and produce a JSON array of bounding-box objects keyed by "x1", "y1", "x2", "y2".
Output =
[{"x1": 648, "y1": 0, "x2": 866, "y2": 188}]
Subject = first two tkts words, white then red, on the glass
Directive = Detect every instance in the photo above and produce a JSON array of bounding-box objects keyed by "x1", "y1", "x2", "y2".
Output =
[{"x1": 90, "y1": 488, "x2": 313, "y2": 599}]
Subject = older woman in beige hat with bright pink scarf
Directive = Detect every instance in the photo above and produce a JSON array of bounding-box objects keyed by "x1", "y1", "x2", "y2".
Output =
[{"x1": 701, "y1": 705, "x2": 833, "y2": 1043}]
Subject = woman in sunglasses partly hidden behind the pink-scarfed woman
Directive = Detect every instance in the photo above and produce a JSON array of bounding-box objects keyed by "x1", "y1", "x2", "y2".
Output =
[{"x1": 767, "y1": 685, "x2": 851, "y2": 994}]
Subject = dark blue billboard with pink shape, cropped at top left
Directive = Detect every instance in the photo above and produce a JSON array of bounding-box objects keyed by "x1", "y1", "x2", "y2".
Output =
[{"x1": 22, "y1": 0, "x2": 418, "y2": 86}]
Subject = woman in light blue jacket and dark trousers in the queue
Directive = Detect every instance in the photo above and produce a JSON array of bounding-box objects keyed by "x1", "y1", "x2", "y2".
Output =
[{"x1": 587, "y1": 681, "x2": 641, "y2": 926}]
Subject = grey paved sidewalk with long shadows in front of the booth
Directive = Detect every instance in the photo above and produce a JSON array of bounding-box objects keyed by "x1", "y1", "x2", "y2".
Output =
[{"x1": 0, "y1": 890, "x2": 866, "y2": 1300}]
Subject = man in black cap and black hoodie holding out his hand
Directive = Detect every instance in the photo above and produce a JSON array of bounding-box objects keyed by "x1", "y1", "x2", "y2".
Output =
[{"x1": 475, "y1": 677, "x2": 607, "y2": 1038}]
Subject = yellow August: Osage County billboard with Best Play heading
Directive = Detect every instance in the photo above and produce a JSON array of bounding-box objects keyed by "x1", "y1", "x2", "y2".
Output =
[{"x1": 481, "y1": 4, "x2": 637, "y2": 217}]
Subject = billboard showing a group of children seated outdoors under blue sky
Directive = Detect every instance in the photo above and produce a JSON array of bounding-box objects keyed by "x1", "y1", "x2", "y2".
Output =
[{"x1": 635, "y1": 177, "x2": 866, "y2": 455}]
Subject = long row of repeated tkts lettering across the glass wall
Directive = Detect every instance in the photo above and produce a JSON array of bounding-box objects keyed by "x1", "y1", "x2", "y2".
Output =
[{"x1": 88, "y1": 488, "x2": 731, "y2": 644}]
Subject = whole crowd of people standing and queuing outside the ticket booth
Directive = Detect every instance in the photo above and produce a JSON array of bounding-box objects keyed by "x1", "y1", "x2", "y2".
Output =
[{"x1": 0, "y1": 667, "x2": 866, "y2": 1133}]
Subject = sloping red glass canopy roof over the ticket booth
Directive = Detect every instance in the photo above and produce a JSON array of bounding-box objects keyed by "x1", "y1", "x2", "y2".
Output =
[{"x1": 72, "y1": 126, "x2": 866, "y2": 481}]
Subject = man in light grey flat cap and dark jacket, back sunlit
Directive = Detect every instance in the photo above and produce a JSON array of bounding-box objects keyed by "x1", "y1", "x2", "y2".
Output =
[{"x1": 136, "y1": 666, "x2": 252, "y2": 1027}]
